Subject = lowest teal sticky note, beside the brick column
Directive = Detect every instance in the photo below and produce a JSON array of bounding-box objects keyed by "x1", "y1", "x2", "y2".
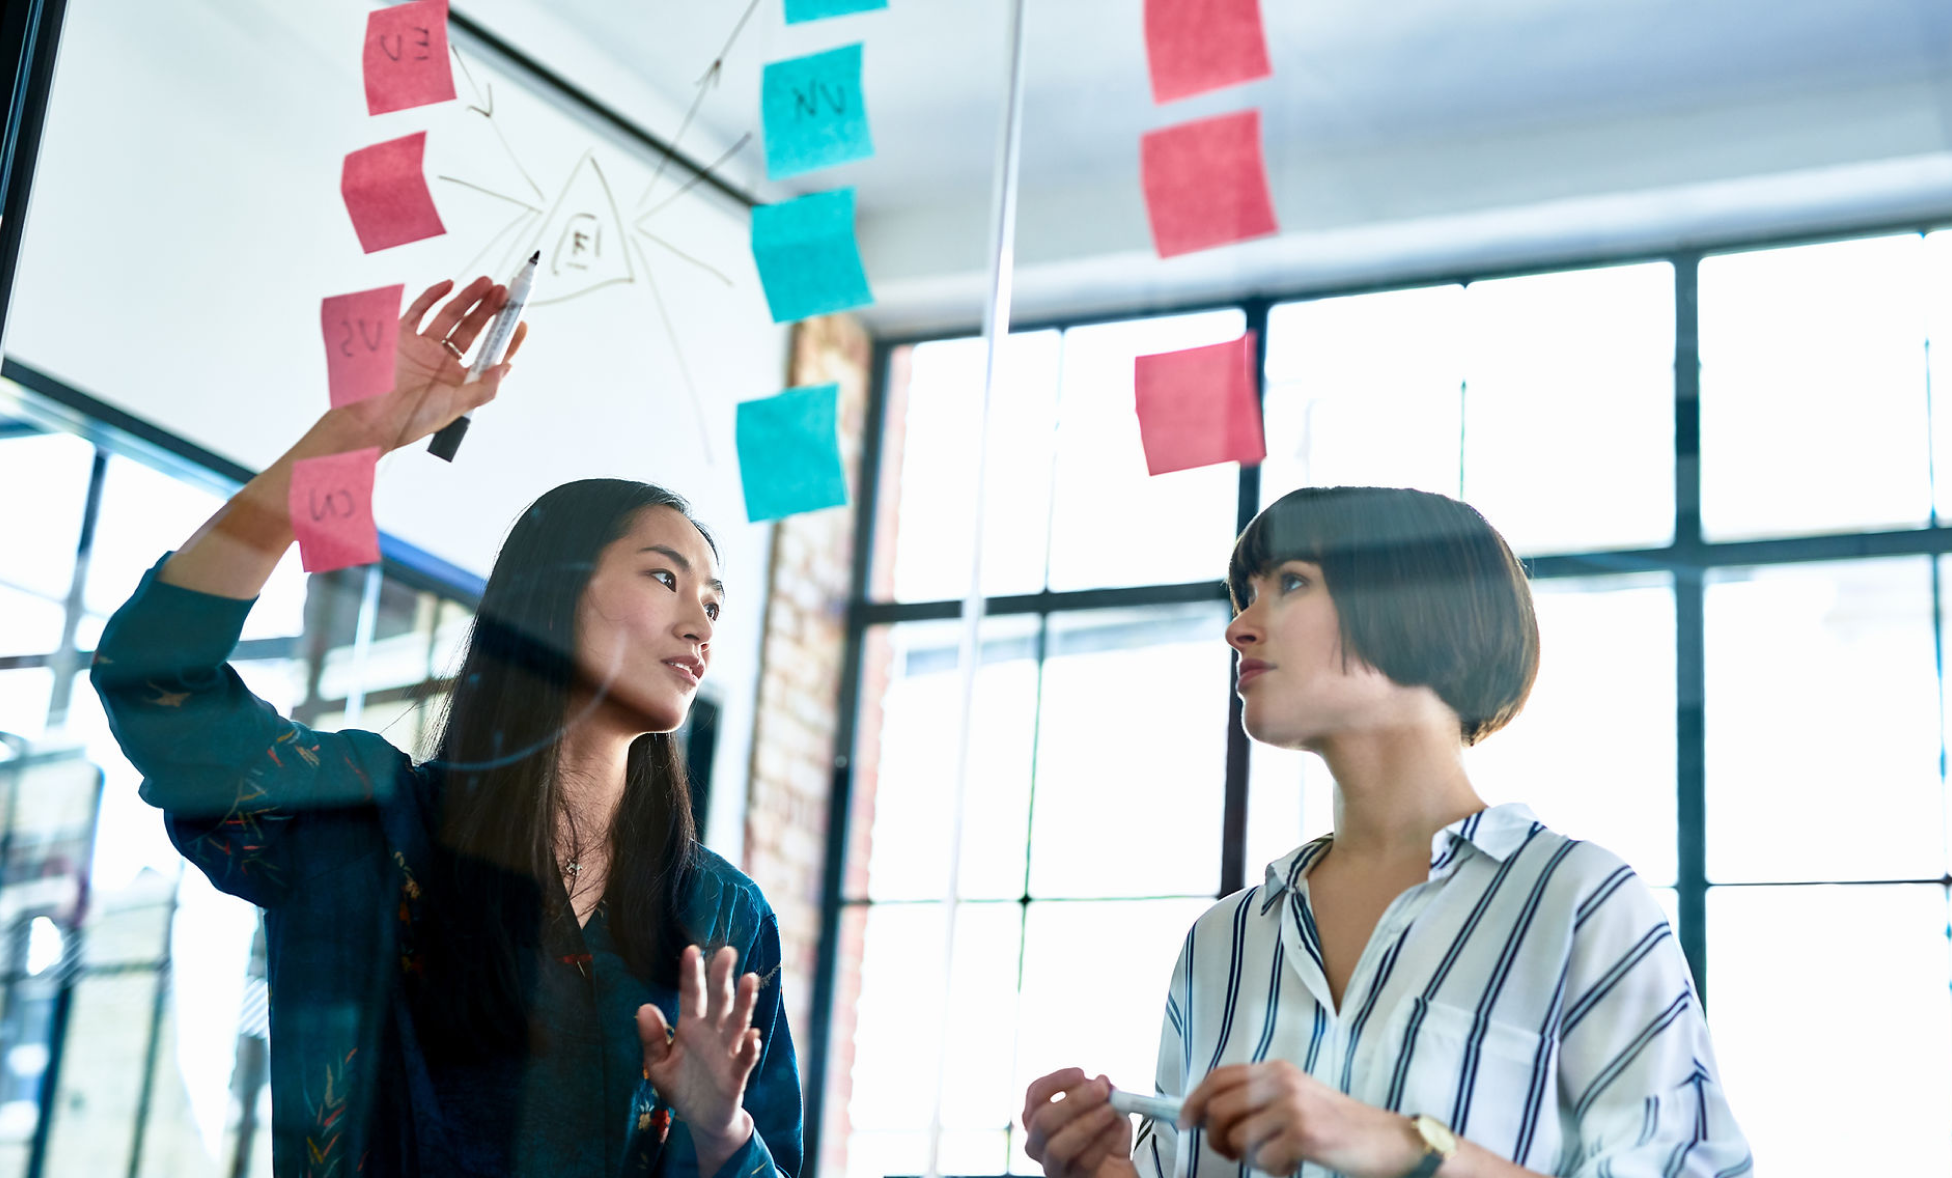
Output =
[{"x1": 738, "y1": 385, "x2": 847, "y2": 524}]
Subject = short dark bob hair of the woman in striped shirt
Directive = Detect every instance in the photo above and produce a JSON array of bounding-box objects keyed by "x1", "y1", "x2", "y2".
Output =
[{"x1": 1226, "y1": 486, "x2": 1538, "y2": 744}]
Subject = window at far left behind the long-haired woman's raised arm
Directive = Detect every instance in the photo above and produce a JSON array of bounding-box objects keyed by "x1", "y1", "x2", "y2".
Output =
[{"x1": 0, "y1": 385, "x2": 484, "y2": 1178}]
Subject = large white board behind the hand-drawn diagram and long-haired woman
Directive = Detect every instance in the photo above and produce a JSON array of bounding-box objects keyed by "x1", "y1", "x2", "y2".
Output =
[{"x1": 4, "y1": 0, "x2": 787, "y2": 848}]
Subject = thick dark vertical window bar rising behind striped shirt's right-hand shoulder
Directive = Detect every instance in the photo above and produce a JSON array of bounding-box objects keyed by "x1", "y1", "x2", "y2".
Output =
[{"x1": 1675, "y1": 254, "x2": 1708, "y2": 1006}]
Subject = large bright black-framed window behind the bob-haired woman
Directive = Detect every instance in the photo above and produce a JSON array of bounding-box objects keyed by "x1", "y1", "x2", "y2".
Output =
[{"x1": 810, "y1": 232, "x2": 1952, "y2": 1178}]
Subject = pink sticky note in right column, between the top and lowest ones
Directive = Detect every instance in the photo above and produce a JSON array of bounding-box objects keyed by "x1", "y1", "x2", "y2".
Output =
[{"x1": 1138, "y1": 111, "x2": 1279, "y2": 258}]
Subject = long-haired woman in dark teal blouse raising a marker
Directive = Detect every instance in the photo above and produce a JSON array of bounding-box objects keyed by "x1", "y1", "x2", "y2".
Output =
[{"x1": 92, "y1": 277, "x2": 800, "y2": 1178}]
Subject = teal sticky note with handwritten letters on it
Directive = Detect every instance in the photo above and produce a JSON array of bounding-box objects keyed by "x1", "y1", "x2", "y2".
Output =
[{"x1": 759, "y1": 43, "x2": 874, "y2": 180}]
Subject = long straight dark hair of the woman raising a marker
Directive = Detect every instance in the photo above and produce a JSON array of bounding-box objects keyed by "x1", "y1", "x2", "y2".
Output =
[{"x1": 410, "y1": 479, "x2": 716, "y2": 1055}]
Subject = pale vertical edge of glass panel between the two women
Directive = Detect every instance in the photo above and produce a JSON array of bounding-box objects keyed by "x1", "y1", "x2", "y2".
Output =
[{"x1": 925, "y1": 0, "x2": 1025, "y2": 1178}]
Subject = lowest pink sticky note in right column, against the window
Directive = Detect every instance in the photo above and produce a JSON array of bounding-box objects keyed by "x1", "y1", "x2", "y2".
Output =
[{"x1": 1132, "y1": 332, "x2": 1267, "y2": 475}]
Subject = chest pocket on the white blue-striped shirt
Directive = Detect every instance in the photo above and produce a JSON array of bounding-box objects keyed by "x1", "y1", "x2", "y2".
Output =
[{"x1": 1386, "y1": 998, "x2": 1558, "y2": 1160}]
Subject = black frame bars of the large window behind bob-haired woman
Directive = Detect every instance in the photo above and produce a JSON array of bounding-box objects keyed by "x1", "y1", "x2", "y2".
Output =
[{"x1": 806, "y1": 219, "x2": 1952, "y2": 1168}]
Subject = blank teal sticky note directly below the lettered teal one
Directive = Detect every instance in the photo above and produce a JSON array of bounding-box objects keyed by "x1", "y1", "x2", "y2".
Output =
[{"x1": 752, "y1": 188, "x2": 874, "y2": 322}]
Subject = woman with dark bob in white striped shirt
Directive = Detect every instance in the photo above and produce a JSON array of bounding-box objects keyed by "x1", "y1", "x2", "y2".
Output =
[{"x1": 1023, "y1": 486, "x2": 1751, "y2": 1178}]
